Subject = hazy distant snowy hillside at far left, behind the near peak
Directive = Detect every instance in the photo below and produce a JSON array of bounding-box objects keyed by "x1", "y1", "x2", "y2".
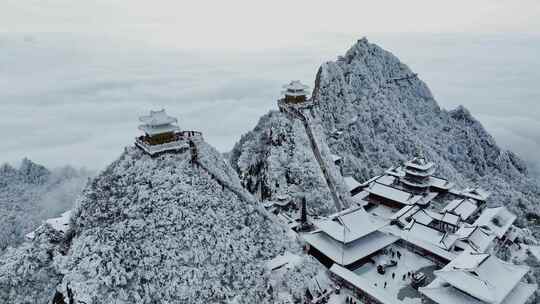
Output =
[{"x1": 0, "y1": 159, "x2": 90, "y2": 252}]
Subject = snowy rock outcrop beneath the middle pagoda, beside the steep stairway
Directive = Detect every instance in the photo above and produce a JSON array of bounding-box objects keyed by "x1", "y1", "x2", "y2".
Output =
[{"x1": 230, "y1": 111, "x2": 345, "y2": 214}]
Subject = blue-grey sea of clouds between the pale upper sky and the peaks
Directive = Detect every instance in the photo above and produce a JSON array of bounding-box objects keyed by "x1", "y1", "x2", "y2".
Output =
[{"x1": 0, "y1": 33, "x2": 540, "y2": 178}]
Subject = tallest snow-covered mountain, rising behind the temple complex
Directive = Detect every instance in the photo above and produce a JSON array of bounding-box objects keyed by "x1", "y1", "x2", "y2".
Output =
[{"x1": 313, "y1": 39, "x2": 540, "y2": 225}]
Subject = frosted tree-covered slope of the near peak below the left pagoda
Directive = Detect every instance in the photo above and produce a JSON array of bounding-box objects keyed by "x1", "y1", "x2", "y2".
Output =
[{"x1": 0, "y1": 142, "x2": 319, "y2": 304}]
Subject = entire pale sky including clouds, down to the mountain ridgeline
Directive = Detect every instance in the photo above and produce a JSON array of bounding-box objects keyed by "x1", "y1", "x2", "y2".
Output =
[{"x1": 0, "y1": 0, "x2": 540, "y2": 177}]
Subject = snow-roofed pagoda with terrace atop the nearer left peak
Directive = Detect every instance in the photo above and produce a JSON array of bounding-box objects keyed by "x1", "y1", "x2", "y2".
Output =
[{"x1": 135, "y1": 109, "x2": 202, "y2": 156}]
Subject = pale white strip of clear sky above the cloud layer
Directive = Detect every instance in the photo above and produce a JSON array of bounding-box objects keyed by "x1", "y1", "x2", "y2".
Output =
[{"x1": 4, "y1": 0, "x2": 540, "y2": 48}]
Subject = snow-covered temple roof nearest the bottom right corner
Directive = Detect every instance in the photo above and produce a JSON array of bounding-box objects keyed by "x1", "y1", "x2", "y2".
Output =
[{"x1": 419, "y1": 251, "x2": 535, "y2": 304}]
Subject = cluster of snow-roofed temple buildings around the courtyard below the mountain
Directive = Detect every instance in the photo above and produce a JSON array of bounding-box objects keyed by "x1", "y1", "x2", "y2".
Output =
[{"x1": 299, "y1": 154, "x2": 537, "y2": 304}]
